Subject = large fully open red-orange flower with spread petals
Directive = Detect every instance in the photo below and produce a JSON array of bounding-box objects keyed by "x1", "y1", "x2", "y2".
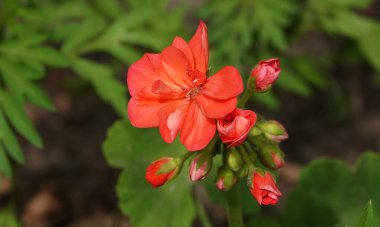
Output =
[{"x1": 127, "y1": 21, "x2": 243, "y2": 151}]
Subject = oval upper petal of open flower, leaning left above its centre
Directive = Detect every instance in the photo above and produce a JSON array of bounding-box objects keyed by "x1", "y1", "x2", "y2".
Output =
[{"x1": 162, "y1": 46, "x2": 191, "y2": 88}]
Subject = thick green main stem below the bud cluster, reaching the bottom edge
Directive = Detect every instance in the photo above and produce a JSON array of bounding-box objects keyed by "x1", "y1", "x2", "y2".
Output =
[{"x1": 226, "y1": 185, "x2": 244, "y2": 227}]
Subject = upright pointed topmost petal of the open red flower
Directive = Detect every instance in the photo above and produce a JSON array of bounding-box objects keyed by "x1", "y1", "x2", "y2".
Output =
[{"x1": 189, "y1": 21, "x2": 209, "y2": 73}]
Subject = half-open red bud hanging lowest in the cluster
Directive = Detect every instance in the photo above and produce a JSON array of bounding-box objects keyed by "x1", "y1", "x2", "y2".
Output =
[{"x1": 250, "y1": 172, "x2": 282, "y2": 205}]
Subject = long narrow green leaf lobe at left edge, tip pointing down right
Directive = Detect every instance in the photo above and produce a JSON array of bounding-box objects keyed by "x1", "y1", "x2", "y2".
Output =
[{"x1": 0, "y1": 90, "x2": 43, "y2": 148}]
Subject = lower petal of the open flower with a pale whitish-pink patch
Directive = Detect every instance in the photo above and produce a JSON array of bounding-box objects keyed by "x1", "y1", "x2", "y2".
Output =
[{"x1": 159, "y1": 100, "x2": 188, "y2": 143}]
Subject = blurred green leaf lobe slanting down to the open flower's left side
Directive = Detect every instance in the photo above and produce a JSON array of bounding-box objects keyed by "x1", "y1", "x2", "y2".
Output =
[{"x1": 72, "y1": 58, "x2": 127, "y2": 116}]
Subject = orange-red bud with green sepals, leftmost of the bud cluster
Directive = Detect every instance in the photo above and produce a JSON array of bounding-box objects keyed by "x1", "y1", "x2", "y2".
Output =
[{"x1": 145, "y1": 157, "x2": 180, "y2": 188}]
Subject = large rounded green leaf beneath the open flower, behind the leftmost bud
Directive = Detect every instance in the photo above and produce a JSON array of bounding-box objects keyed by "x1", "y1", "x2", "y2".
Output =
[{"x1": 103, "y1": 120, "x2": 195, "y2": 227}]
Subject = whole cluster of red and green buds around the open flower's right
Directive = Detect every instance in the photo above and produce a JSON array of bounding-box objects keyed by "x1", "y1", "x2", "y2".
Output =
[{"x1": 146, "y1": 58, "x2": 288, "y2": 205}]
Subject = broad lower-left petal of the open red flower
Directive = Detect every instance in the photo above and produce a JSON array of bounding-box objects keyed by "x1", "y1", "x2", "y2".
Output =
[{"x1": 128, "y1": 87, "x2": 173, "y2": 128}]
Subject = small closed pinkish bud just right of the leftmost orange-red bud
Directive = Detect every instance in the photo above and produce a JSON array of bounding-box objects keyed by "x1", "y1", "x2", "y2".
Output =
[{"x1": 189, "y1": 153, "x2": 212, "y2": 181}]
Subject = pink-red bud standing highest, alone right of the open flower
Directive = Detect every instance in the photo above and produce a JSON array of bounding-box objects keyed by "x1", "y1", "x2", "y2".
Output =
[{"x1": 251, "y1": 58, "x2": 281, "y2": 92}]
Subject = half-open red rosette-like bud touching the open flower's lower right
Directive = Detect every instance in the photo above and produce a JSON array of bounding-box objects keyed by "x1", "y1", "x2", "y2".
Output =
[{"x1": 217, "y1": 108, "x2": 256, "y2": 147}]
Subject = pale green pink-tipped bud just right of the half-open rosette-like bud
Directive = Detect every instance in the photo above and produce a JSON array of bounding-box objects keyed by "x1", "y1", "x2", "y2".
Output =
[{"x1": 256, "y1": 120, "x2": 288, "y2": 143}]
